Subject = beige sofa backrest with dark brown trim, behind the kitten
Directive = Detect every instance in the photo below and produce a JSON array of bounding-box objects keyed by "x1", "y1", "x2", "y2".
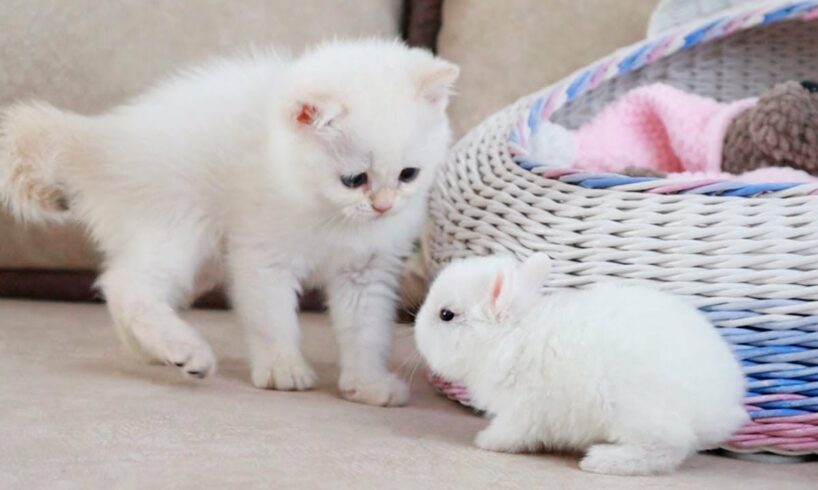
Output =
[{"x1": 0, "y1": 0, "x2": 655, "y2": 304}]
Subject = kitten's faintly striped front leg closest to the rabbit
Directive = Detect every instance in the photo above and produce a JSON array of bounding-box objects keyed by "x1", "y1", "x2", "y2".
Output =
[{"x1": 327, "y1": 253, "x2": 409, "y2": 406}]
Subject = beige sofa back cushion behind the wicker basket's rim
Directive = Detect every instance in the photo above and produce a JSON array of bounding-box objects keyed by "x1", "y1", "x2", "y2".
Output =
[{"x1": 437, "y1": 0, "x2": 656, "y2": 136}]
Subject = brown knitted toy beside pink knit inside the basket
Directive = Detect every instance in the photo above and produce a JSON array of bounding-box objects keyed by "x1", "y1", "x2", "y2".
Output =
[{"x1": 624, "y1": 81, "x2": 818, "y2": 177}]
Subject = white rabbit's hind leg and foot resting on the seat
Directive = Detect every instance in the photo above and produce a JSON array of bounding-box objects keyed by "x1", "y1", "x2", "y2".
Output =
[{"x1": 579, "y1": 409, "x2": 696, "y2": 475}]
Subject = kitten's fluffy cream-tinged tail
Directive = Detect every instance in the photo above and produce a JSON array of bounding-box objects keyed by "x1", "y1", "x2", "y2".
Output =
[{"x1": 0, "y1": 103, "x2": 89, "y2": 222}]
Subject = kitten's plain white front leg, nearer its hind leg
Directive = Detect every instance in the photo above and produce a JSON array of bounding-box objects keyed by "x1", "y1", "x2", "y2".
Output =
[{"x1": 231, "y1": 251, "x2": 315, "y2": 390}]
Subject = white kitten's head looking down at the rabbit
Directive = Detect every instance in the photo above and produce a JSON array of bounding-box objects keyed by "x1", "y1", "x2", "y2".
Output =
[{"x1": 282, "y1": 41, "x2": 459, "y2": 223}]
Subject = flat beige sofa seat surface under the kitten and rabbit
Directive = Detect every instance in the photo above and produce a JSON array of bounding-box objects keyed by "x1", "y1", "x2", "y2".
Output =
[{"x1": 0, "y1": 301, "x2": 818, "y2": 490}]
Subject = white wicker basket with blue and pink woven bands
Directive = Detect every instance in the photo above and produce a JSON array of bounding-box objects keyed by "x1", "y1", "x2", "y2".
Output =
[{"x1": 426, "y1": 0, "x2": 818, "y2": 455}]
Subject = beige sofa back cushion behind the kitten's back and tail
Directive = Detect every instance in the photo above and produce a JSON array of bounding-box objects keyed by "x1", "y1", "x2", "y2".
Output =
[{"x1": 0, "y1": 0, "x2": 401, "y2": 269}]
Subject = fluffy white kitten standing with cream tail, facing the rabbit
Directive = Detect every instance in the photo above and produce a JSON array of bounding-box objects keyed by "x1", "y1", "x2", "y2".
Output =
[{"x1": 0, "y1": 41, "x2": 458, "y2": 405}]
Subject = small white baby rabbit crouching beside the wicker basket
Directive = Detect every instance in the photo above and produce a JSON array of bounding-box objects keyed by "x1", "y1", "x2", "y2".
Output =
[{"x1": 415, "y1": 254, "x2": 747, "y2": 475}]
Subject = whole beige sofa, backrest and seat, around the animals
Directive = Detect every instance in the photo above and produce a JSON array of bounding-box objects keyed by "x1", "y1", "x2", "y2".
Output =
[{"x1": 9, "y1": 0, "x2": 800, "y2": 489}]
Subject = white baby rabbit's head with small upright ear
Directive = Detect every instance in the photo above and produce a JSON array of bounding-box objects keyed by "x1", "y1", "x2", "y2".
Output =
[{"x1": 415, "y1": 253, "x2": 551, "y2": 381}]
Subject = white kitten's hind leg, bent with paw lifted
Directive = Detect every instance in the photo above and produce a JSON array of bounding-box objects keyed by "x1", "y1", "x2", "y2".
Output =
[{"x1": 99, "y1": 242, "x2": 216, "y2": 378}]
